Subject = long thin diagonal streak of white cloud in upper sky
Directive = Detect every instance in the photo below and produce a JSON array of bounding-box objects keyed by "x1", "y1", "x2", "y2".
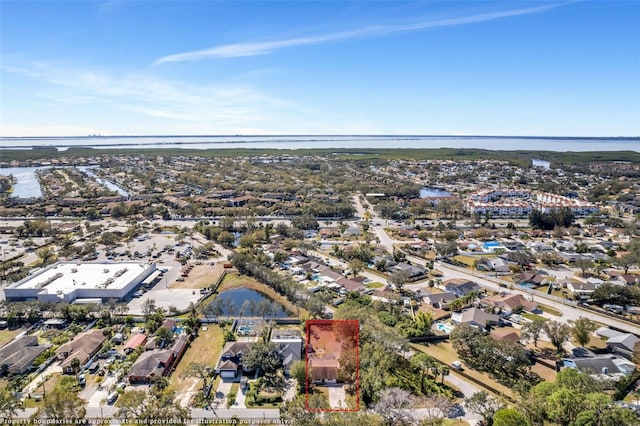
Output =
[{"x1": 155, "y1": 1, "x2": 575, "y2": 65}]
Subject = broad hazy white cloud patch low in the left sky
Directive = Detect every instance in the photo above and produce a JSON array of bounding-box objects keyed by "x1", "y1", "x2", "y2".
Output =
[{"x1": 1, "y1": 63, "x2": 292, "y2": 133}]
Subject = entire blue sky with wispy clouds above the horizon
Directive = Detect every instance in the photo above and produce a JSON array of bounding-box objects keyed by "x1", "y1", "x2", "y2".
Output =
[{"x1": 0, "y1": 0, "x2": 640, "y2": 136}]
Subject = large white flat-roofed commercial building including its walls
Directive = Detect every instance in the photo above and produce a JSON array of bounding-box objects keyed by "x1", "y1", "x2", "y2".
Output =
[{"x1": 4, "y1": 262, "x2": 156, "y2": 303}]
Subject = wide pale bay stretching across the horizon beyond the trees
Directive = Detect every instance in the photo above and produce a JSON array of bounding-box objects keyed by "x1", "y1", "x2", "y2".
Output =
[{"x1": 0, "y1": 135, "x2": 640, "y2": 152}]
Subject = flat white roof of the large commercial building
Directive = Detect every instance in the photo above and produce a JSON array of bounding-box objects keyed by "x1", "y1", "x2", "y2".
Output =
[{"x1": 13, "y1": 262, "x2": 153, "y2": 294}]
